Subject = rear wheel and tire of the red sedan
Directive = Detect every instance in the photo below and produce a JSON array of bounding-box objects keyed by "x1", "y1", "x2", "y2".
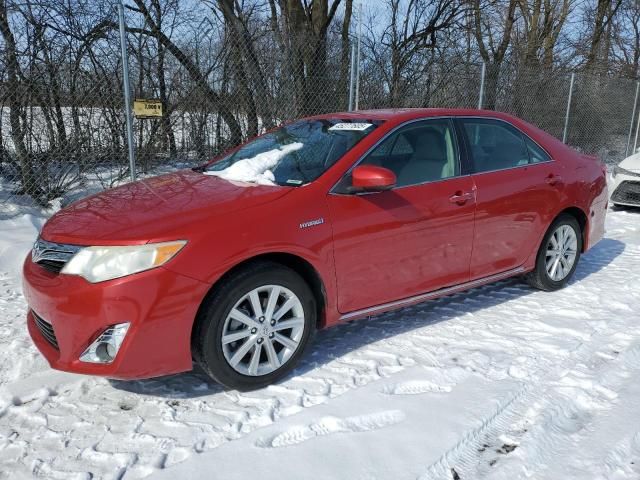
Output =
[{"x1": 525, "y1": 214, "x2": 582, "y2": 292}]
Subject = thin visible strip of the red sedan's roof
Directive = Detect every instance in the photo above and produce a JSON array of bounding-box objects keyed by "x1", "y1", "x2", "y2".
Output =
[{"x1": 313, "y1": 108, "x2": 514, "y2": 121}]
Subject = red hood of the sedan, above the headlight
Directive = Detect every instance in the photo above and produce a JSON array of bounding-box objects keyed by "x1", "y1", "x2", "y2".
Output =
[{"x1": 41, "y1": 170, "x2": 292, "y2": 245}]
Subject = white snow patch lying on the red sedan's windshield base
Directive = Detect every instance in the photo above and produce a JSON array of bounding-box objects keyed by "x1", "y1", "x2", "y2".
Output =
[{"x1": 204, "y1": 142, "x2": 304, "y2": 185}]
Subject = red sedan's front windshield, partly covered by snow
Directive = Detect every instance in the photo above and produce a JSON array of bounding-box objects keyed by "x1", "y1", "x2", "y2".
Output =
[{"x1": 204, "y1": 119, "x2": 380, "y2": 186}]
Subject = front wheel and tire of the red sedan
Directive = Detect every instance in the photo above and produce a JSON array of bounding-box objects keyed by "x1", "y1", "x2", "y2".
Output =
[{"x1": 192, "y1": 262, "x2": 317, "y2": 390}]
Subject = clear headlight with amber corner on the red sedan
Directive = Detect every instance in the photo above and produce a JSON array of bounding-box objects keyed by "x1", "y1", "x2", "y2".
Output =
[{"x1": 61, "y1": 240, "x2": 187, "y2": 283}]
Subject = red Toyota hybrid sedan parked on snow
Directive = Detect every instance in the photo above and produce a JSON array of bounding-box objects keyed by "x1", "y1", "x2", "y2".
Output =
[{"x1": 24, "y1": 109, "x2": 607, "y2": 389}]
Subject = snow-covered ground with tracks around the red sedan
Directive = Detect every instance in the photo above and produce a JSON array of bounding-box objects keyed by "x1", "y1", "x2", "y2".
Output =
[{"x1": 0, "y1": 201, "x2": 640, "y2": 480}]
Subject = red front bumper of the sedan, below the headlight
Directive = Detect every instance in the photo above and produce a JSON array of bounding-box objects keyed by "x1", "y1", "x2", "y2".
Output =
[{"x1": 23, "y1": 255, "x2": 210, "y2": 379}]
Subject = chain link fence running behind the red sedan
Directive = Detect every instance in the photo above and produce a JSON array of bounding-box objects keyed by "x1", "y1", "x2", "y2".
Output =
[{"x1": 0, "y1": 11, "x2": 640, "y2": 215}]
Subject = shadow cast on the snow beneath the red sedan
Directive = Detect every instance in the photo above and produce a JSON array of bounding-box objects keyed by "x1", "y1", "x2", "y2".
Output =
[{"x1": 110, "y1": 238, "x2": 625, "y2": 399}]
